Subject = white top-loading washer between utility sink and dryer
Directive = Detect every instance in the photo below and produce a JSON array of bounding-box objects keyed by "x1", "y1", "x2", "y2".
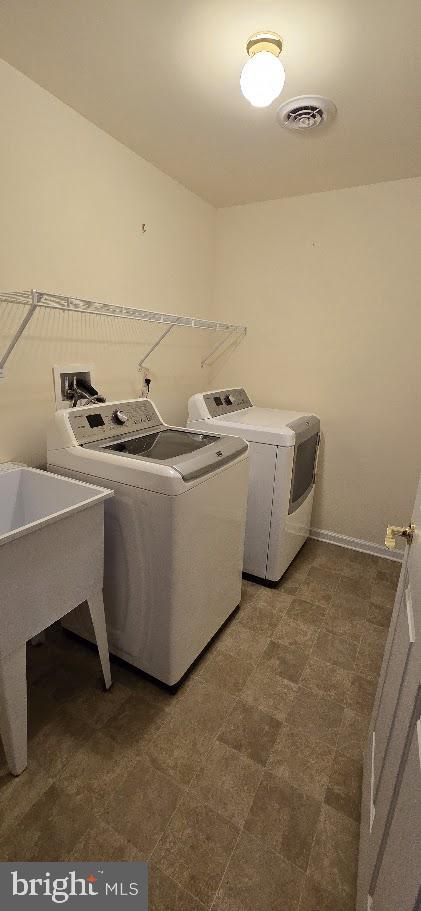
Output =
[{"x1": 48, "y1": 399, "x2": 248, "y2": 685}]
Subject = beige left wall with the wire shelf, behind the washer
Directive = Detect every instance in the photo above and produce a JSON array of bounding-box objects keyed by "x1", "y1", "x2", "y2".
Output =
[{"x1": 0, "y1": 62, "x2": 215, "y2": 465}]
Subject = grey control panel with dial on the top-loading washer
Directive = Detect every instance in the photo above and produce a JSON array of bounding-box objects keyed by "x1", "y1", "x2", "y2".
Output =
[{"x1": 67, "y1": 399, "x2": 163, "y2": 446}]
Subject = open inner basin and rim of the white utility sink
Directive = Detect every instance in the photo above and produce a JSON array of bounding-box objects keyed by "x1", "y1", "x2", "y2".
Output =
[{"x1": 0, "y1": 466, "x2": 110, "y2": 546}]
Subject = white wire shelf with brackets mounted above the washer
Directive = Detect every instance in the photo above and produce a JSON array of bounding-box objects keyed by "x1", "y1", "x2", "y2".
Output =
[{"x1": 0, "y1": 290, "x2": 247, "y2": 378}]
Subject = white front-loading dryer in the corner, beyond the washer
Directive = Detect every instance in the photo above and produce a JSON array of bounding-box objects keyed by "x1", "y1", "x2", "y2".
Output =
[{"x1": 188, "y1": 389, "x2": 320, "y2": 583}]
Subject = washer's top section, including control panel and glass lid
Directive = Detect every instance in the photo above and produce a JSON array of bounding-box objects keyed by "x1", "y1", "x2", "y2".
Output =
[{"x1": 47, "y1": 399, "x2": 248, "y2": 496}]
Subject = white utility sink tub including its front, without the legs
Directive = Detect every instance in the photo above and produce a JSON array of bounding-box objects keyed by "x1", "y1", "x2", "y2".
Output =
[{"x1": 0, "y1": 465, "x2": 113, "y2": 658}]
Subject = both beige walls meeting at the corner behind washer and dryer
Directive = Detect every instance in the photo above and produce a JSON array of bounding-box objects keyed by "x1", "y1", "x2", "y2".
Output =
[{"x1": 0, "y1": 62, "x2": 421, "y2": 556}]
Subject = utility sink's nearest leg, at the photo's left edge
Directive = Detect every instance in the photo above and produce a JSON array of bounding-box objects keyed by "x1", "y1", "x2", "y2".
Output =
[{"x1": 0, "y1": 642, "x2": 28, "y2": 775}]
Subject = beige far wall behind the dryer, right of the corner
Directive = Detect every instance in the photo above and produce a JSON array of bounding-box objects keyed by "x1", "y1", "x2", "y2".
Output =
[{"x1": 213, "y1": 178, "x2": 421, "y2": 543}]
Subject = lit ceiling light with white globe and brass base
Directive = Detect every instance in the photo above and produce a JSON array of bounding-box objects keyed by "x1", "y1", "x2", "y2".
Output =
[{"x1": 240, "y1": 32, "x2": 285, "y2": 108}]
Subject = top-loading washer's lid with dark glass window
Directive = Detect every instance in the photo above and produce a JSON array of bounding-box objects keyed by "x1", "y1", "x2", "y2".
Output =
[{"x1": 84, "y1": 425, "x2": 247, "y2": 481}]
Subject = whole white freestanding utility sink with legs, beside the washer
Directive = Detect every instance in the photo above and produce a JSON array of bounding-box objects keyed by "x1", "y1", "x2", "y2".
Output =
[{"x1": 0, "y1": 464, "x2": 113, "y2": 775}]
